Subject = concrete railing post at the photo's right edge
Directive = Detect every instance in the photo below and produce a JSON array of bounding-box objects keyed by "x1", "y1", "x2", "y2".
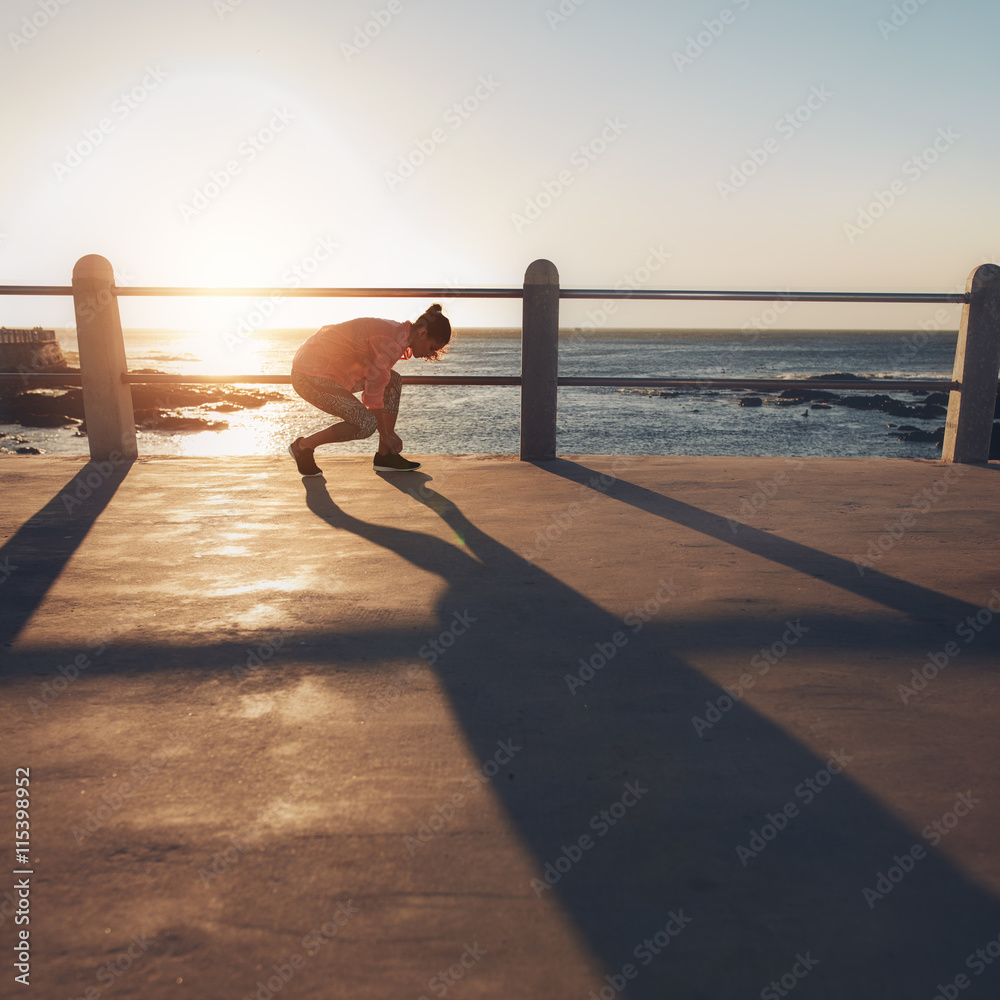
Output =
[{"x1": 941, "y1": 264, "x2": 1000, "y2": 464}]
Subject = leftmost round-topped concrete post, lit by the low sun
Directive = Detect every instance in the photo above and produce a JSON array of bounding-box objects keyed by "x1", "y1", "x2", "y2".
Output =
[{"x1": 73, "y1": 254, "x2": 138, "y2": 461}]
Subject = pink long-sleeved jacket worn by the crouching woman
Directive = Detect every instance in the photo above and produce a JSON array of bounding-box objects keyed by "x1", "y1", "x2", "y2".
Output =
[{"x1": 292, "y1": 317, "x2": 410, "y2": 410}]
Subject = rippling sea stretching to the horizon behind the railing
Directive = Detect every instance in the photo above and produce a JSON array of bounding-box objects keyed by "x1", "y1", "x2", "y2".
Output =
[{"x1": 0, "y1": 329, "x2": 957, "y2": 458}]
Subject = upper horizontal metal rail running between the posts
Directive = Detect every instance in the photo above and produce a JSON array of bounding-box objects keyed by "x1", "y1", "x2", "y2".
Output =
[{"x1": 0, "y1": 285, "x2": 969, "y2": 305}]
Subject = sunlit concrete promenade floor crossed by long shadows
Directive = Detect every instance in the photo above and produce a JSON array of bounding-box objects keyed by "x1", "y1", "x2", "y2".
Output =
[{"x1": 0, "y1": 453, "x2": 1000, "y2": 1000}]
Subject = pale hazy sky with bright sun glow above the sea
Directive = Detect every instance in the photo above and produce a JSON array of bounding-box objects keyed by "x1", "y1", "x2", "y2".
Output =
[{"x1": 0, "y1": 0, "x2": 1000, "y2": 330}]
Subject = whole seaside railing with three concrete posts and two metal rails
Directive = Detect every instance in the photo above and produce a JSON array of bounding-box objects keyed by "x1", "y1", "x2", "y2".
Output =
[{"x1": 0, "y1": 255, "x2": 1000, "y2": 462}]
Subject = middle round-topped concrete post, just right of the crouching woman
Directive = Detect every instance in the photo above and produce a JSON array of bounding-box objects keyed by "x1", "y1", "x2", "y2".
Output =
[{"x1": 521, "y1": 260, "x2": 559, "y2": 462}]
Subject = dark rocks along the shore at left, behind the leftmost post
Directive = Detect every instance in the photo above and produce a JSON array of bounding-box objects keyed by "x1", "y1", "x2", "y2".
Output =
[{"x1": 0, "y1": 367, "x2": 286, "y2": 455}]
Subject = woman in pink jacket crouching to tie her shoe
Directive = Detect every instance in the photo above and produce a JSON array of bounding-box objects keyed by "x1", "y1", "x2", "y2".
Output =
[{"x1": 288, "y1": 302, "x2": 451, "y2": 476}]
